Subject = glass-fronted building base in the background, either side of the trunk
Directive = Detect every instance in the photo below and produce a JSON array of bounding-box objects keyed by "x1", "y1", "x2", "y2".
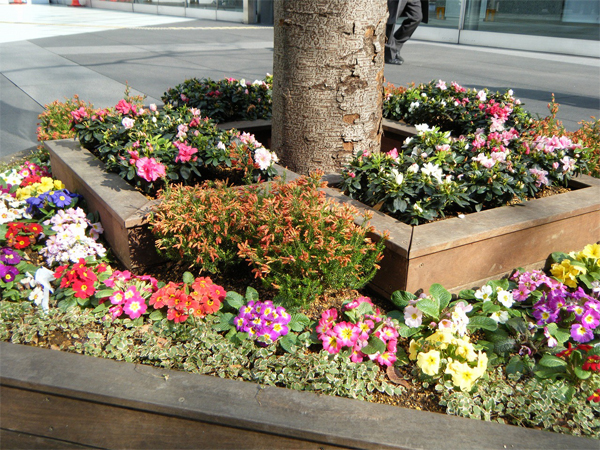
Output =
[{"x1": 50, "y1": 0, "x2": 600, "y2": 58}]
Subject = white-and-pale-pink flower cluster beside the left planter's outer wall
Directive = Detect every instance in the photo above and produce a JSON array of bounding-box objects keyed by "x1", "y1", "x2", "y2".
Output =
[{"x1": 40, "y1": 207, "x2": 106, "y2": 266}]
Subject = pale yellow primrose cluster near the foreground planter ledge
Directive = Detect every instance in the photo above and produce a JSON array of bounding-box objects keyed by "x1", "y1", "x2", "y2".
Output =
[{"x1": 409, "y1": 329, "x2": 488, "y2": 392}]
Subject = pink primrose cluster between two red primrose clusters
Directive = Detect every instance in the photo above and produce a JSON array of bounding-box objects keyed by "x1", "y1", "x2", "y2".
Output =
[{"x1": 99, "y1": 270, "x2": 158, "y2": 320}]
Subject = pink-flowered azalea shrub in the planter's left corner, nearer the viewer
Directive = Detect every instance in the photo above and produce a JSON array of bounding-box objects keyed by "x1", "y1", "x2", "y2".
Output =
[{"x1": 73, "y1": 99, "x2": 277, "y2": 194}]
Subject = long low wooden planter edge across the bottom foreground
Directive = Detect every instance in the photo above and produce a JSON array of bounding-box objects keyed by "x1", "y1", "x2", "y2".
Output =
[{"x1": 0, "y1": 342, "x2": 598, "y2": 450}]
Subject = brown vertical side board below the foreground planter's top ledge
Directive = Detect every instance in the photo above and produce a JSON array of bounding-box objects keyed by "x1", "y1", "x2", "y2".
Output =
[{"x1": 0, "y1": 387, "x2": 340, "y2": 450}]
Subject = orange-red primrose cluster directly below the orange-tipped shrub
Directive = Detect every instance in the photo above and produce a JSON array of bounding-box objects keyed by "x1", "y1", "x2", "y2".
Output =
[{"x1": 149, "y1": 277, "x2": 225, "y2": 323}]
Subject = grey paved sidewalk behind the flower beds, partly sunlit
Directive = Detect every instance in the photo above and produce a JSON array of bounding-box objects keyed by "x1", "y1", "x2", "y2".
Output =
[{"x1": 0, "y1": 5, "x2": 600, "y2": 157}]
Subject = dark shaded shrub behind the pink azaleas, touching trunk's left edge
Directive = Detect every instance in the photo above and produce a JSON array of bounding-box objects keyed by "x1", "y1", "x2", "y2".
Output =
[{"x1": 162, "y1": 75, "x2": 273, "y2": 123}]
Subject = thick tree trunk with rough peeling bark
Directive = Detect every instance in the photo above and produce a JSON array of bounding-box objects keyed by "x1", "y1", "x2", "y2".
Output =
[{"x1": 272, "y1": 0, "x2": 388, "y2": 174}]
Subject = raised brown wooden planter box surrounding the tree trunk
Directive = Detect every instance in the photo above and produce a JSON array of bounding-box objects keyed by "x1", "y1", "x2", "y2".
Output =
[{"x1": 45, "y1": 120, "x2": 600, "y2": 298}]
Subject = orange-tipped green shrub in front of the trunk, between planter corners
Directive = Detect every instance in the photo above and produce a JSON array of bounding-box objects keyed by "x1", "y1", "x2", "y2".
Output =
[{"x1": 151, "y1": 175, "x2": 383, "y2": 306}]
